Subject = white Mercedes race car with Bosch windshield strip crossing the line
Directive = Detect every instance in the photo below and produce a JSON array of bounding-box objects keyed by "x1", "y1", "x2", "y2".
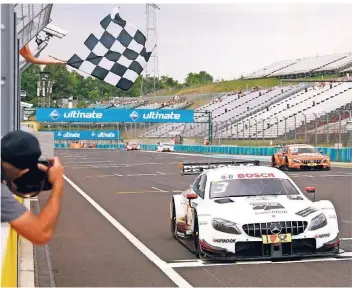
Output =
[{"x1": 170, "y1": 161, "x2": 341, "y2": 260}]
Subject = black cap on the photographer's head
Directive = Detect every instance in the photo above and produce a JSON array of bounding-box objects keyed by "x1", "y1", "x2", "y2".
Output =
[{"x1": 1, "y1": 130, "x2": 42, "y2": 169}]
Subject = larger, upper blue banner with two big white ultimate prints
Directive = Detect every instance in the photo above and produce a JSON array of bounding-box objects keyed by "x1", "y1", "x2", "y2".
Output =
[{"x1": 35, "y1": 108, "x2": 194, "y2": 123}]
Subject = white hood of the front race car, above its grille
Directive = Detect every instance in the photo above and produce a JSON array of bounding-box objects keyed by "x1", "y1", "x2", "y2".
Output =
[{"x1": 206, "y1": 195, "x2": 318, "y2": 224}]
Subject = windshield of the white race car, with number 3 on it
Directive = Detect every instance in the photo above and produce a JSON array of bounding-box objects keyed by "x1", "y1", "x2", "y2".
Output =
[{"x1": 209, "y1": 178, "x2": 300, "y2": 199}]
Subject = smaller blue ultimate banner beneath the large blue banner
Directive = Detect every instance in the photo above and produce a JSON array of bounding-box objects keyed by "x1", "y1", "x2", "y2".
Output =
[{"x1": 53, "y1": 130, "x2": 120, "y2": 140}]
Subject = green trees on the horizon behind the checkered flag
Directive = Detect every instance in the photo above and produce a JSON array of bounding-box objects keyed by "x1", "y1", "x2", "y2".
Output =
[{"x1": 21, "y1": 65, "x2": 213, "y2": 108}]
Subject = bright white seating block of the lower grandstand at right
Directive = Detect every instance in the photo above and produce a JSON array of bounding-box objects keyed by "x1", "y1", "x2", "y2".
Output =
[{"x1": 215, "y1": 82, "x2": 352, "y2": 139}]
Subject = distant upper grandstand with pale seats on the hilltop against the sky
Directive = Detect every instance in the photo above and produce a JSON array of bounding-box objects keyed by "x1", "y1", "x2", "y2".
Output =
[{"x1": 244, "y1": 53, "x2": 352, "y2": 79}]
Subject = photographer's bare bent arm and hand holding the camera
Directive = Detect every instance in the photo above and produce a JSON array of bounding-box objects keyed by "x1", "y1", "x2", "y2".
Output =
[{"x1": 10, "y1": 157, "x2": 64, "y2": 245}]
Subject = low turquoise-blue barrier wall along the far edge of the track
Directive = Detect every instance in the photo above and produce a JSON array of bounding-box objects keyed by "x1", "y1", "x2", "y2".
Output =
[{"x1": 55, "y1": 144, "x2": 352, "y2": 162}]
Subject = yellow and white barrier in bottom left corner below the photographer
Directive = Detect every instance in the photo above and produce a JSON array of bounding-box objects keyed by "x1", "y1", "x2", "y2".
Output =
[{"x1": 1, "y1": 197, "x2": 23, "y2": 287}]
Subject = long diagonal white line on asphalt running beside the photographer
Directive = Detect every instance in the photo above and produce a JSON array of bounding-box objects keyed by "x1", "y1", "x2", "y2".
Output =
[{"x1": 64, "y1": 175, "x2": 192, "y2": 287}]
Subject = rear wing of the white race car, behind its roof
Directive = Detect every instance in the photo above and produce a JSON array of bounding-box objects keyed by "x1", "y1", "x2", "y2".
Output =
[{"x1": 180, "y1": 160, "x2": 260, "y2": 176}]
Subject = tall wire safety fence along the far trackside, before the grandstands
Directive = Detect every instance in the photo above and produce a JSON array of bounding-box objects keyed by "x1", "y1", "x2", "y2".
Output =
[{"x1": 40, "y1": 109, "x2": 352, "y2": 147}]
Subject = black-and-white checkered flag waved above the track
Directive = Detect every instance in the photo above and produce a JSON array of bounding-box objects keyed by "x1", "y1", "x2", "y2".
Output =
[{"x1": 67, "y1": 9, "x2": 155, "y2": 91}]
